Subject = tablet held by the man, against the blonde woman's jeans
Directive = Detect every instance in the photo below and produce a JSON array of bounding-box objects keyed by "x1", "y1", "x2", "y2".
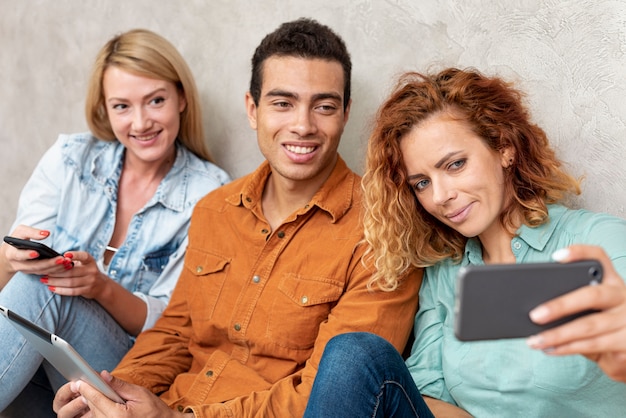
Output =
[{"x1": 0, "y1": 306, "x2": 124, "y2": 403}]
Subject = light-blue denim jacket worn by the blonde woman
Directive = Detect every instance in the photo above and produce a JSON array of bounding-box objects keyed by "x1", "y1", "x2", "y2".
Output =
[{"x1": 11, "y1": 133, "x2": 230, "y2": 329}]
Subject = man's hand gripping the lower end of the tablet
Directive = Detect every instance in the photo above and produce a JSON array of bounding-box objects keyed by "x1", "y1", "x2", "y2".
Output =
[{"x1": 53, "y1": 371, "x2": 194, "y2": 418}]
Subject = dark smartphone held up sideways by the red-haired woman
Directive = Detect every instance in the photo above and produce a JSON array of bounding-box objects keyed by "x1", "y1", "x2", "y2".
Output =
[{"x1": 454, "y1": 260, "x2": 603, "y2": 341}]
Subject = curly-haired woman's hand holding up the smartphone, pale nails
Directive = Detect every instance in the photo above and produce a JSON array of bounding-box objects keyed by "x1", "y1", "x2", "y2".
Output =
[{"x1": 528, "y1": 245, "x2": 626, "y2": 382}]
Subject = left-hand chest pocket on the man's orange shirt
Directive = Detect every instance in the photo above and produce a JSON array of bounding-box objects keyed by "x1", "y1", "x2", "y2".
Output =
[{"x1": 185, "y1": 248, "x2": 230, "y2": 322}]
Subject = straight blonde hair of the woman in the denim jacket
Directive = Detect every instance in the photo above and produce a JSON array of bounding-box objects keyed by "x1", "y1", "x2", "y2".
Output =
[{"x1": 85, "y1": 29, "x2": 213, "y2": 161}]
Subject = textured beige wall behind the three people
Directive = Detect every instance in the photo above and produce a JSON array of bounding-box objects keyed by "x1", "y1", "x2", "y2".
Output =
[{"x1": 0, "y1": 0, "x2": 626, "y2": 232}]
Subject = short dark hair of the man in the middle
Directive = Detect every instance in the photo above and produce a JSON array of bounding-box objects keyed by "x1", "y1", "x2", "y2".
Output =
[{"x1": 250, "y1": 18, "x2": 352, "y2": 110}]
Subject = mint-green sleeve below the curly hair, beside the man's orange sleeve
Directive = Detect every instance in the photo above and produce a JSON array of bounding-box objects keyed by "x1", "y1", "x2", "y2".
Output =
[{"x1": 406, "y1": 267, "x2": 456, "y2": 405}]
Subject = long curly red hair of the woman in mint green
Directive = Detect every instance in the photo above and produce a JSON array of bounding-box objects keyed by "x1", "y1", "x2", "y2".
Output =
[{"x1": 362, "y1": 68, "x2": 580, "y2": 290}]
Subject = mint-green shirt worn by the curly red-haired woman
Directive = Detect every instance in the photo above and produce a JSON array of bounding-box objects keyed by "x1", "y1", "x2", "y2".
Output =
[{"x1": 406, "y1": 205, "x2": 626, "y2": 418}]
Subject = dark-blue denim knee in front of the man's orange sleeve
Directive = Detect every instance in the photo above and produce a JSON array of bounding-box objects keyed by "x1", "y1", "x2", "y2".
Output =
[{"x1": 304, "y1": 332, "x2": 433, "y2": 418}]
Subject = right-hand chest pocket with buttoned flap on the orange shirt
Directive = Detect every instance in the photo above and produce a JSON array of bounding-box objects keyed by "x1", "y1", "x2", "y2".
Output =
[{"x1": 267, "y1": 274, "x2": 343, "y2": 350}]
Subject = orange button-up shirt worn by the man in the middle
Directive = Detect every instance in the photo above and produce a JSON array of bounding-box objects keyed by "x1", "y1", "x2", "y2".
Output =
[{"x1": 113, "y1": 158, "x2": 421, "y2": 418}]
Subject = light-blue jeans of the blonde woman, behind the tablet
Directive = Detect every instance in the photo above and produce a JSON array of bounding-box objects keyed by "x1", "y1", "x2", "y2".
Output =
[{"x1": 0, "y1": 273, "x2": 134, "y2": 411}]
